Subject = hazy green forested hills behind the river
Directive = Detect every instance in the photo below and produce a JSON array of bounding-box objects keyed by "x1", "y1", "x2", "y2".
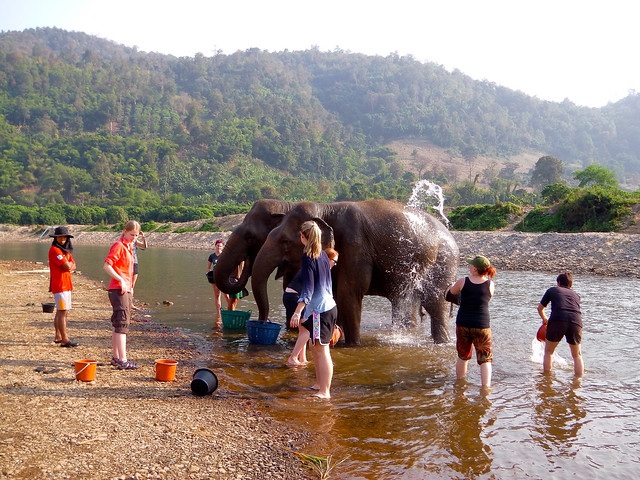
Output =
[{"x1": 0, "y1": 28, "x2": 640, "y2": 211}]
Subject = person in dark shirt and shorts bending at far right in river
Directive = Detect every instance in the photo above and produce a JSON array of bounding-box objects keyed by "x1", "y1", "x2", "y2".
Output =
[{"x1": 538, "y1": 272, "x2": 584, "y2": 377}]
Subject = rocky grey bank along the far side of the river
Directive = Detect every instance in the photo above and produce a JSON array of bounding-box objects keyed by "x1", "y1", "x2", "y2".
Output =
[{"x1": 0, "y1": 224, "x2": 640, "y2": 278}]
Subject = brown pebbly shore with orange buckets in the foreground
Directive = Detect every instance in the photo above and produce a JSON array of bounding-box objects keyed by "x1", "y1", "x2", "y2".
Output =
[{"x1": 0, "y1": 261, "x2": 312, "y2": 480}]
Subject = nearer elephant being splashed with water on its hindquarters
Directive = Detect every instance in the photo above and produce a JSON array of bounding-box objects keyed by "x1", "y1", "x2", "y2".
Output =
[{"x1": 251, "y1": 200, "x2": 458, "y2": 345}]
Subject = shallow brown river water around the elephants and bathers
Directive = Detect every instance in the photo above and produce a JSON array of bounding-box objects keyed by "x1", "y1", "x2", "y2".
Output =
[{"x1": 0, "y1": 241, "x2": 640, "y2": 480}]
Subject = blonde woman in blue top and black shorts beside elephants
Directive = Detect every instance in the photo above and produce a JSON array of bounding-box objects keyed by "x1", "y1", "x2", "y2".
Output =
[{"x1": 290, "y1": 220, "x2": 338, "y2": 398}]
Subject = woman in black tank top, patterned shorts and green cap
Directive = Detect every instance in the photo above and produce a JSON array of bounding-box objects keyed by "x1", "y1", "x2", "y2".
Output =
[{"x1": 448, "y1": 255, "x2": 496, "y2": 388}]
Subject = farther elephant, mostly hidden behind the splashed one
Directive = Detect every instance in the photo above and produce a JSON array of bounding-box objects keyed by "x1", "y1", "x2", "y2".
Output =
[{"x1": 213, "y1": 199, "x2": 296, "y2": 294}]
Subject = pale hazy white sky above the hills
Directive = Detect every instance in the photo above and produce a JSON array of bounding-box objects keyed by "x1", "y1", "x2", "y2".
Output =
[{"x1": 0, "y1": 0, "x2": 640, "y2": 107}]
